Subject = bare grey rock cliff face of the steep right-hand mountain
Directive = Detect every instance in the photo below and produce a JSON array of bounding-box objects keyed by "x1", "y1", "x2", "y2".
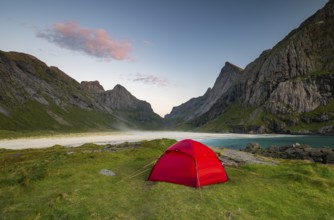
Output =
[{"x1": 243, "y1": 1, "x2": 334, "y2": 111}]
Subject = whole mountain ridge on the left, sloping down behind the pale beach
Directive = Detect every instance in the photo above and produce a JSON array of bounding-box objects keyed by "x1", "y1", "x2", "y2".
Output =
[{"x1": 0, "y1": 51, "x2": 162, "y2": 131}]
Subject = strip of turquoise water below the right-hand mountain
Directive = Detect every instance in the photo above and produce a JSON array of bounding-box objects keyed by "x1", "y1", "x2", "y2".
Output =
[{"x1": 199, "y1": 135, "x2": 334, "y2": 149}]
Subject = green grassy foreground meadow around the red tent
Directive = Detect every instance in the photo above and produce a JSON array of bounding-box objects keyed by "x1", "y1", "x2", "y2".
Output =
[{"x1": 0, "y1": 139, "x2": 334, "y2": 219}]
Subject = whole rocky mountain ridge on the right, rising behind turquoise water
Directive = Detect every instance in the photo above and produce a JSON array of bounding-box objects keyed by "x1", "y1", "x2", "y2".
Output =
[{"x1": 166, "y1": 0, "x2": 334, "y2": 134}]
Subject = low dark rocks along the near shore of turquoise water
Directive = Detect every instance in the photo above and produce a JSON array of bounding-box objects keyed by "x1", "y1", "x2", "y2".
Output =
[{"x1": 243, "y1": 143, "x2": 334, "y2": 164}]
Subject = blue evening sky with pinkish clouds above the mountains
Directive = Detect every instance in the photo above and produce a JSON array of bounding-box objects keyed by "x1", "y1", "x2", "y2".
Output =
[{"x1": 0, "y1": 0, "x2": 327, "y2": 116}]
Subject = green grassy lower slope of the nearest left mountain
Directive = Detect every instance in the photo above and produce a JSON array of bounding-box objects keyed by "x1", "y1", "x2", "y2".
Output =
[{"x1": 0, "y1": 101, "x2": 118, "y2": 133}]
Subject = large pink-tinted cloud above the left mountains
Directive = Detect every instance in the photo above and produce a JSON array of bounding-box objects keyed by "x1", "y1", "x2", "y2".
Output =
[{"x1": 37, "y1": 22, "x2": 132, "y2": 61}]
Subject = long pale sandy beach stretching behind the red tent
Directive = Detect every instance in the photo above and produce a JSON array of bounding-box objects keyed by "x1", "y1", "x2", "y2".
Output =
[{"x1": 0, "y1": 131, "x2": 264, "y2": 149}]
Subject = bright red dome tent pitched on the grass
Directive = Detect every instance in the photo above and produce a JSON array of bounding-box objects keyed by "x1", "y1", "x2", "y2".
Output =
[{"x1": 148, "y1": 139, "x2": 228, "y2": 187}]
